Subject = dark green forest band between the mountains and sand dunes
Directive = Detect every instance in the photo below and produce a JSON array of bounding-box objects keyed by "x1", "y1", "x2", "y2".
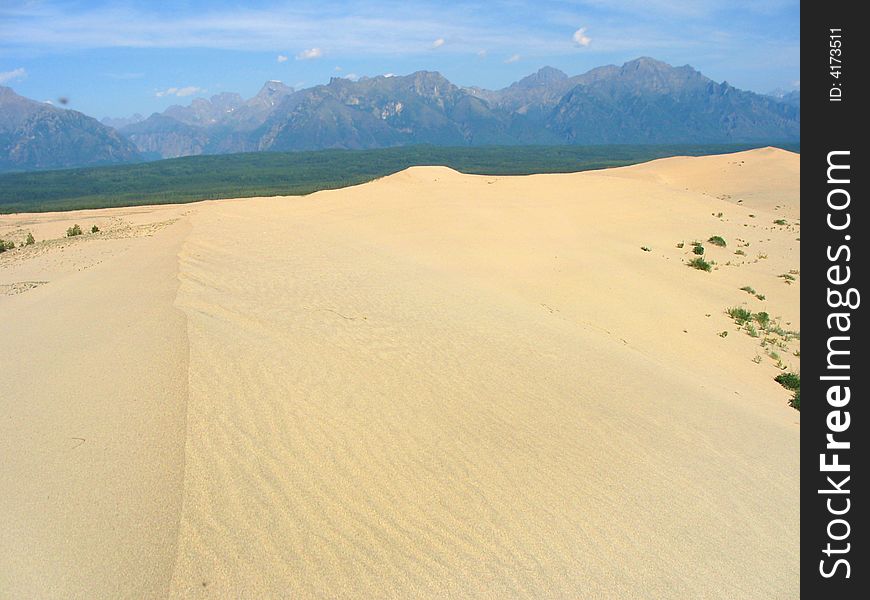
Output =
[{"x1": 0, "y1": 144, "x2": 800, "y2": 213}]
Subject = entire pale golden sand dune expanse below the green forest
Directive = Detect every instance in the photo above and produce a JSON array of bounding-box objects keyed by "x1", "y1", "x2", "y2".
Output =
[{"x1": 0, "y1": 149, "x2": 800, "y2": 599}]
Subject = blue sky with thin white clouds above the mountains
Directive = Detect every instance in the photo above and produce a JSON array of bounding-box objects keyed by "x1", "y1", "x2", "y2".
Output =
[{"x1": 0, "y1": 0, "x2": 800, "y2": 118}]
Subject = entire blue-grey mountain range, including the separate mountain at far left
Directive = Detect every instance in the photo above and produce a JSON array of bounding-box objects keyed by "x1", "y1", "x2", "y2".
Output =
[{"x1": 0, "y1": 57, "x2": 800, "y2": 170}]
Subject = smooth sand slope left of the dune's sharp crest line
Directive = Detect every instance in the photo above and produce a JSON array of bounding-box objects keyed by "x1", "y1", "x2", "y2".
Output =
[{"x1": 0, "y1": 209, "x2": 189, "y2": 598}]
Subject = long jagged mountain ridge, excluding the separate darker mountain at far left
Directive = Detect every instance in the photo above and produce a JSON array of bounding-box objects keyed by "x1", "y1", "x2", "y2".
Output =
[{"x1": 121, "y1": 57, "x2": 800, "y2": 157}]
